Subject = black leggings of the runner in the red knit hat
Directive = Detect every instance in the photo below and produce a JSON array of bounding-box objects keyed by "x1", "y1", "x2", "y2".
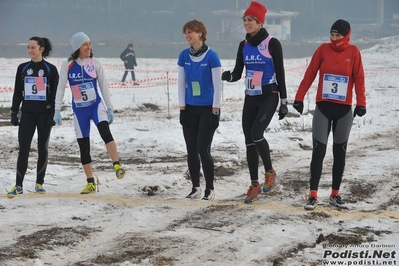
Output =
[{"x1": 242, "y1": 93, "x2": 278, "y2": 181}]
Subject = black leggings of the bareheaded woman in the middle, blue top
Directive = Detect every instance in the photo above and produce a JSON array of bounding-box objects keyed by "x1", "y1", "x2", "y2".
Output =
[{"x1": 183, "y1": 105, "x2": 216, "y2": 190}]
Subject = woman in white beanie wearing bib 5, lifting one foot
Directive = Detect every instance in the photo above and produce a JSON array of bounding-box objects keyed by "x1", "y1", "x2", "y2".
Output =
[{"x1": 54, "y1": 32, "x2": 125, "y2": 194}]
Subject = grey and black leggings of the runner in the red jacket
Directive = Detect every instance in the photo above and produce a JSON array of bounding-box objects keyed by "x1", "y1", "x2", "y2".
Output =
[{"x1": 310, "y1": 102, "x2": 353, "y2": 190}]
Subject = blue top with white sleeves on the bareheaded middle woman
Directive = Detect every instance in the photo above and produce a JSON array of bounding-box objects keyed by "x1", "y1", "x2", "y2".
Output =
[{"x1": 177, "y1": 48, "x2": 222, "y2": 108}]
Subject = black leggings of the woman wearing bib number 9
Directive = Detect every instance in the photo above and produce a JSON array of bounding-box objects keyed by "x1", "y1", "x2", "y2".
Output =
[{"x1": 16, "y1": 112, "x2": 53, "y2": 187}]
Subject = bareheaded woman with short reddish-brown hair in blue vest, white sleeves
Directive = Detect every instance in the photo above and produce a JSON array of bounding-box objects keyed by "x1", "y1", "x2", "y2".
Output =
[{"x1": 177, "y1": 20, "x2": 222, "y2": 200}]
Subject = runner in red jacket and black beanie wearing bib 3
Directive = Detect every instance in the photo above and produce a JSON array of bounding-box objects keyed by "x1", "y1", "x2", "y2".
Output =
[{"x1": 293, "y1": 19, "x2": 366, "y2": 210}]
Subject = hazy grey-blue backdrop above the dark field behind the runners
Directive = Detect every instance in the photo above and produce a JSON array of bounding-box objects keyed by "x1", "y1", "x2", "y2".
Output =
[{"x1": 0, "y1": 0, "x2": 399, "y2": 45}]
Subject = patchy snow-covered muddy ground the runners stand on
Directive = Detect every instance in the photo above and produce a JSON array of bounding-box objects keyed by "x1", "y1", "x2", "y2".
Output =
[{"x1": 0, "y1": 36, "x2": 399, "y2": 266}]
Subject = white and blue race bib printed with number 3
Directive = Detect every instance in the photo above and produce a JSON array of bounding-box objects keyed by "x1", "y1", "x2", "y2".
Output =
[{"x1": 322, "y1": 74, "x2": 349, "y2": 101}]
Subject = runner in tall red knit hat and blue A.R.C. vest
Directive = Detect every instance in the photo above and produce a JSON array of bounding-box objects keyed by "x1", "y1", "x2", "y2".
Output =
[{"x1": 222, "y1": 1, "x2": 288, "y2": 203}]
